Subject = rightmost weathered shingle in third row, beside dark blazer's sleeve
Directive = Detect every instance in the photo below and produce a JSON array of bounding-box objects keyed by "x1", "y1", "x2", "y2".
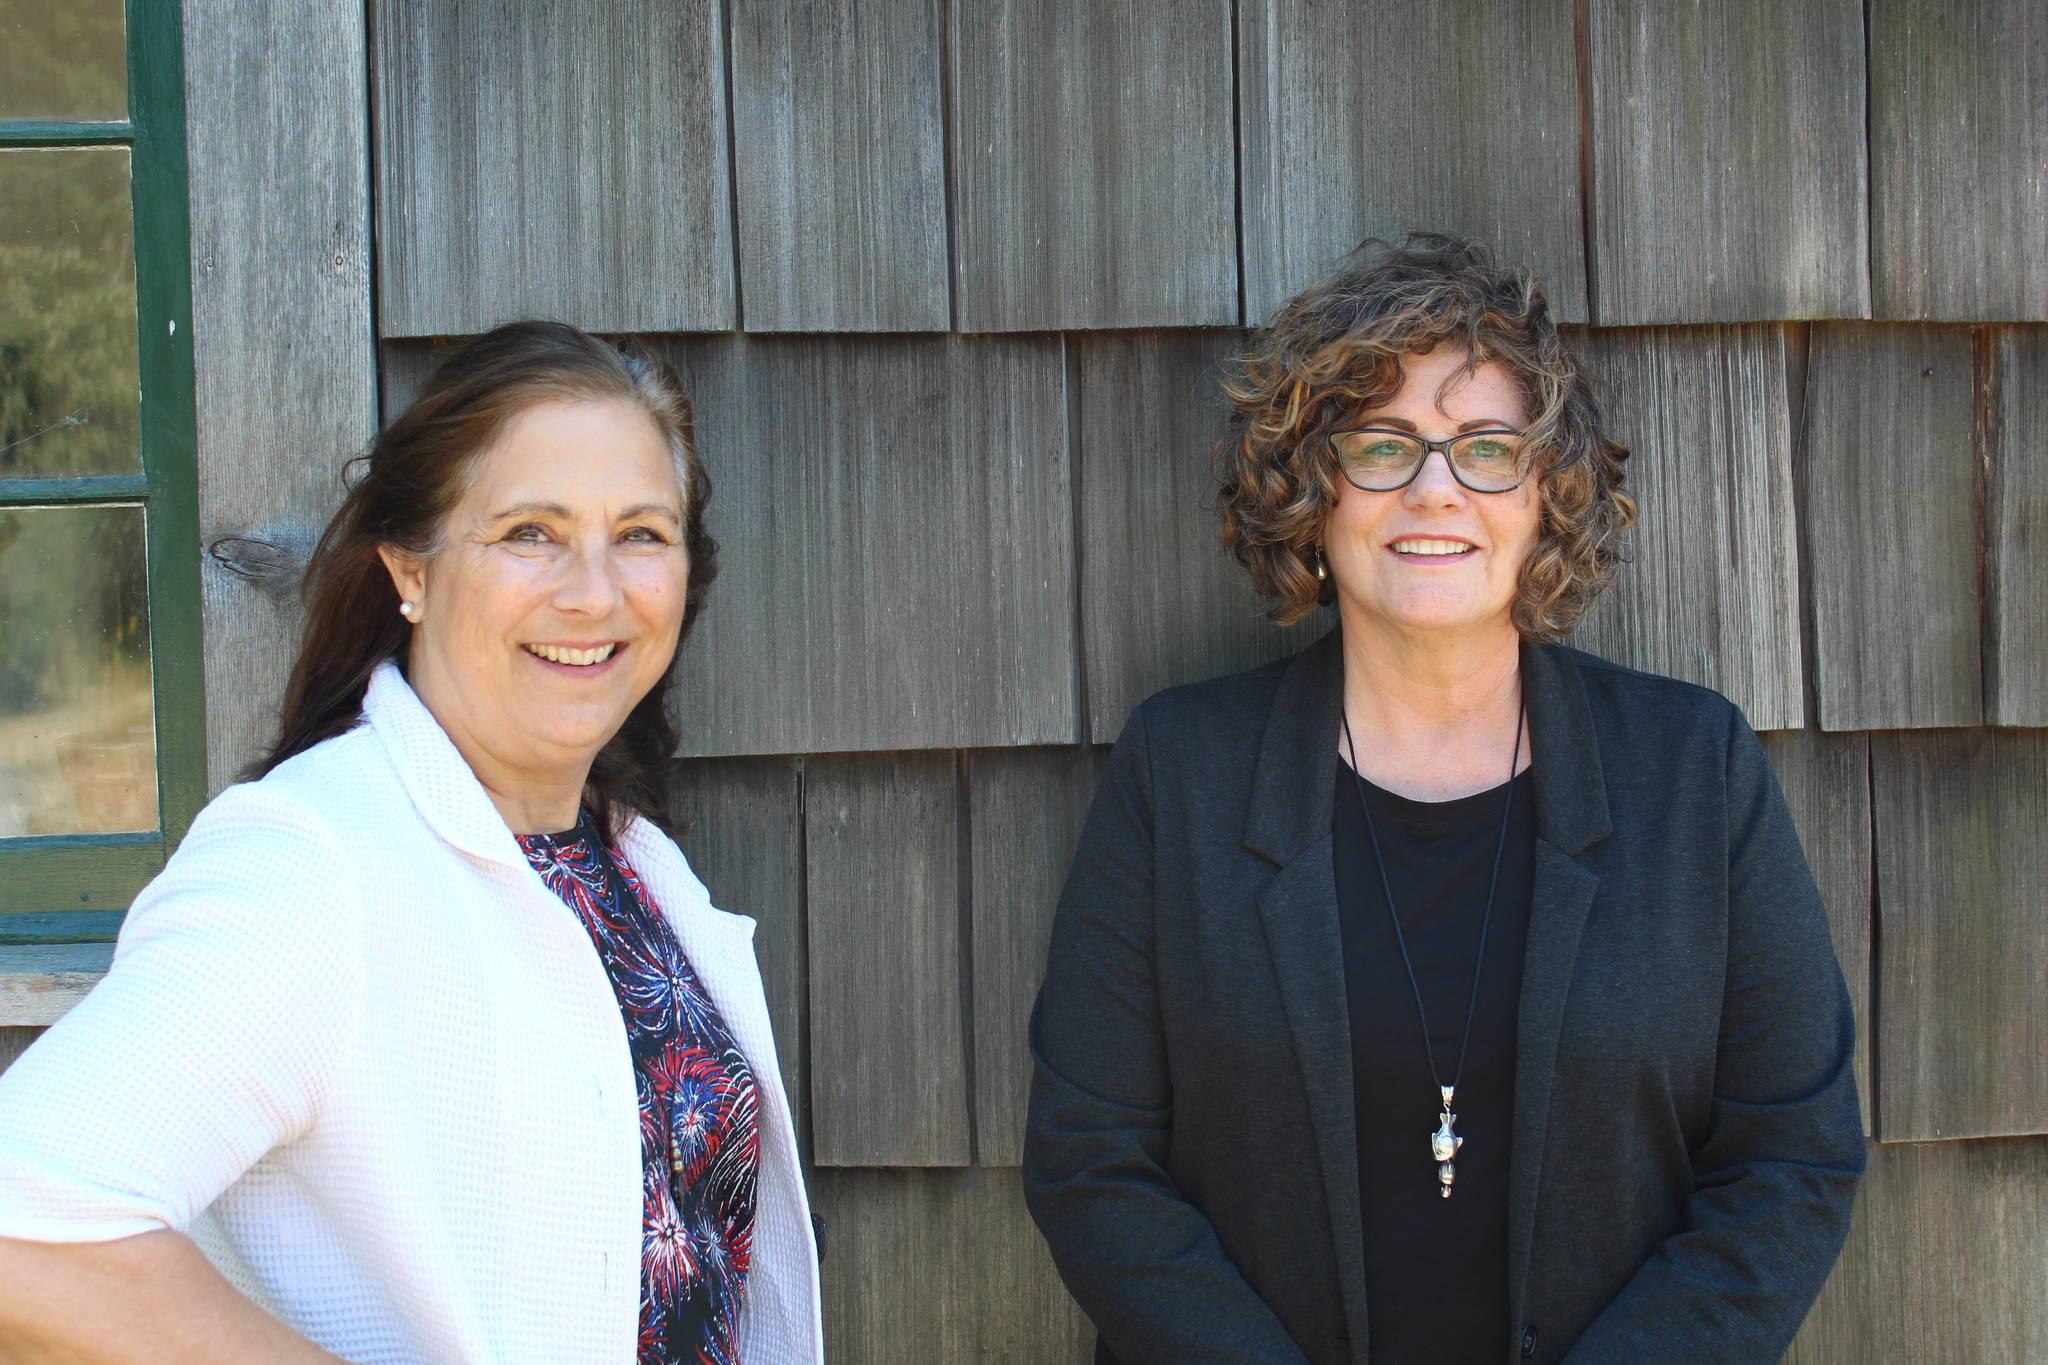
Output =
[{"x1": 1872, "y1": 731, "x2": 2048, "y2": 1142}]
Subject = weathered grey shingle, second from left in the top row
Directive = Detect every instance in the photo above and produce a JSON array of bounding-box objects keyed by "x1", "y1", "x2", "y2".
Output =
[{"x1": 731, "y1": 0, "x2": 950, "y2": 332}]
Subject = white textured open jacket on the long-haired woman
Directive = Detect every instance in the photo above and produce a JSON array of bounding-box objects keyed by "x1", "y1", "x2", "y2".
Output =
[{"x1": 0, "y1": 663, "x2": 823, "y2": 1365}]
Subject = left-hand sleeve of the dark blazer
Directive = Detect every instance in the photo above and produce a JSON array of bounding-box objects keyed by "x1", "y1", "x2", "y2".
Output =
[{"x1": 1024, "y1": 708, "x2": 1307, "y2": 1365}]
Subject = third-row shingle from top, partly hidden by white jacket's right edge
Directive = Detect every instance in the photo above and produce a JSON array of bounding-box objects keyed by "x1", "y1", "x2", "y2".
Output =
[{"x1": 670, "y1": 757, "x2": 811, "y2": 1152}]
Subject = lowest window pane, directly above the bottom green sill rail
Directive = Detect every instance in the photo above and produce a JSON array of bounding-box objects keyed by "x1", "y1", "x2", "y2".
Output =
[{"x1": 0, "y1": 505, "x2": 156, "y2": 839}]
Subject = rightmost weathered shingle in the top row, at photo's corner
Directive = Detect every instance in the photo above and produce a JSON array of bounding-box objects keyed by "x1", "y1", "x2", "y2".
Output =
[{"x1": 1870, "y1": 0, "x2": 2048, "y2": 321}]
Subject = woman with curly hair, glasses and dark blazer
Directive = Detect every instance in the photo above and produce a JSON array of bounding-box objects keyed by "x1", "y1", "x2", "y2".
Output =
[{"x1": 1024, "y1": 233, "x2": 1864, "y2": 1365}]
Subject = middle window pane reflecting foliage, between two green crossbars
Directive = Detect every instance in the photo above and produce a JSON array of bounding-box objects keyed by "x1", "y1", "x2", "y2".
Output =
[{"x1": 0, "y1": 147, "x2": 141, "y2": 479}]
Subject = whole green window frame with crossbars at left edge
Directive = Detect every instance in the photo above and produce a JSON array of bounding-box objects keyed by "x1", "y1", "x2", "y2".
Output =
[{"x1": 0, "y1": 0, "x2": 207, "y2": 943}]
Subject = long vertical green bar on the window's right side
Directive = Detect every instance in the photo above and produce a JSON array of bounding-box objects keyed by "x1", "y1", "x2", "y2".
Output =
[{"x1": 127, "y1": 0, "x2": 207, "y2": 845}]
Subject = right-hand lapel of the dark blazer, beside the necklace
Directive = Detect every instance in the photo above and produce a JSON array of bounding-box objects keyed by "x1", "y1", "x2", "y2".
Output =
[{"x1": 1507, "y1": 645, "x2": 1614, "y2": 1328}]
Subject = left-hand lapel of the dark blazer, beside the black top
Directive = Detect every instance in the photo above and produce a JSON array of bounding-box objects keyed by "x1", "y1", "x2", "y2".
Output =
[{"x1": 1243, "y1": 630, "x2": 1366, "y2": 1365}]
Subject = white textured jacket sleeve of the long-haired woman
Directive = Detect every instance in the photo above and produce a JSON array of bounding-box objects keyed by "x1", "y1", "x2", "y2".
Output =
[{"x1": 0, "y1": 784, "x2": 360, "y2": 1242}]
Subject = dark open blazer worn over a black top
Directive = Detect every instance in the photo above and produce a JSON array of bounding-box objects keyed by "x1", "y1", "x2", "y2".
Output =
[{"x1": 1024, "y1": 634, "x2": 1864, "y2": 1365}]
